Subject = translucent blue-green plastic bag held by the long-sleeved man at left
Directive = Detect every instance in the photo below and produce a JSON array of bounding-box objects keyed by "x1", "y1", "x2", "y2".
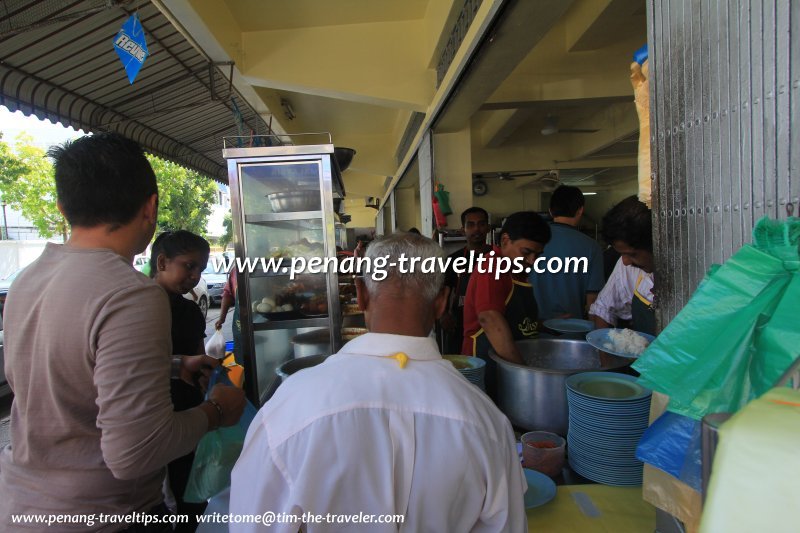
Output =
[{"x1": 183, "y1": 367, "x2": 258, "y2": 503}]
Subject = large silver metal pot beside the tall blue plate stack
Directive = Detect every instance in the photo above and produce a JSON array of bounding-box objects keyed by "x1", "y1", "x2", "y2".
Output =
[{"x1": 489, "y1": 339, "x2": 631, "y2": 436}]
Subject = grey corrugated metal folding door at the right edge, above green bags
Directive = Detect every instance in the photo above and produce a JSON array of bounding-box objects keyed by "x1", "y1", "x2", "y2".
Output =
[{"x1": 647, "y1": 0, "x2": 800, "y2": 327}]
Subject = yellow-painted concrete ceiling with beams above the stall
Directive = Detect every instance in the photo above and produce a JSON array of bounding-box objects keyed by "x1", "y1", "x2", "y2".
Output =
[{"x1": 161, "y1": 0, "x2": 646, "y2": 196}]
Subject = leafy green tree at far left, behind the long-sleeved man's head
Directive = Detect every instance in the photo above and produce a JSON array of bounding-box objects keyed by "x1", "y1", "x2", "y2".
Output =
[{"x1": 0, "y1": 132, "x2": 69, "y2": 240}]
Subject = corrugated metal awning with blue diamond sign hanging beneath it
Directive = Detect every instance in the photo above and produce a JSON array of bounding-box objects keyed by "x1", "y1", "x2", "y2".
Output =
[{"x1": 0, "y1": 0, "x2": 271, "y2": 182}]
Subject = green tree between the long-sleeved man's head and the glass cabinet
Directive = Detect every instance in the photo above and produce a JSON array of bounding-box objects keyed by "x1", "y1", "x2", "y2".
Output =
[{"x1": 147, "y1": 154, "x2": 217, "y2": 236}]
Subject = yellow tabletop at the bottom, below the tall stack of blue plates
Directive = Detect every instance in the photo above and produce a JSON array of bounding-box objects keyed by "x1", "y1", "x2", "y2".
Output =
[{"x1": 527, "y1": 485, "x2": 656, "y2": 533}]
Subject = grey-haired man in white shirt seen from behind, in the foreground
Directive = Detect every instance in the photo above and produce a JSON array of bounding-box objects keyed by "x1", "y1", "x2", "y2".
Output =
[{"x1": 230, "y1": 234, "x2": 527, "y2": 532}]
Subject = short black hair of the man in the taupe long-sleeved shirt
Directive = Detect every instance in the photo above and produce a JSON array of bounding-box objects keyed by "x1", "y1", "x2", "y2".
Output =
[{"x1": 48, "y1": 133, "x2": 158, "y2": 229}]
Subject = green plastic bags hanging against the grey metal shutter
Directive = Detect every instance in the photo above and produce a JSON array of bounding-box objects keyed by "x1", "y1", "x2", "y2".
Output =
[{"x1": 633, "y1": 217, "x2": 800, "y2": 420}]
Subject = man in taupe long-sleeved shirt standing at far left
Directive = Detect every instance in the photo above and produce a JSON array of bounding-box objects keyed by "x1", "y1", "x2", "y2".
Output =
[{"x1": 0, "y1": 135, "x2": 244, "y2": 531}]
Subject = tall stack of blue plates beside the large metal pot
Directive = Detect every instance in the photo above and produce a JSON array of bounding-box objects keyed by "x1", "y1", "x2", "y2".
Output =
[{"x1": 566, "y1": 372, "x2": 652, "y2": 486}]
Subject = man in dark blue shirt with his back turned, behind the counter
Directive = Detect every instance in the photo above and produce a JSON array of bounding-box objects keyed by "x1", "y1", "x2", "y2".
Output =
[{"x1": 529, "y1": 185, "x2": 605, "y2": 320}]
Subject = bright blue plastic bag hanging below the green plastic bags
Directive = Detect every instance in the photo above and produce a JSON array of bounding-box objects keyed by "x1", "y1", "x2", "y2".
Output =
[{"x1": 636, "y1": 411, "x2": 702, "y2": 492}]
